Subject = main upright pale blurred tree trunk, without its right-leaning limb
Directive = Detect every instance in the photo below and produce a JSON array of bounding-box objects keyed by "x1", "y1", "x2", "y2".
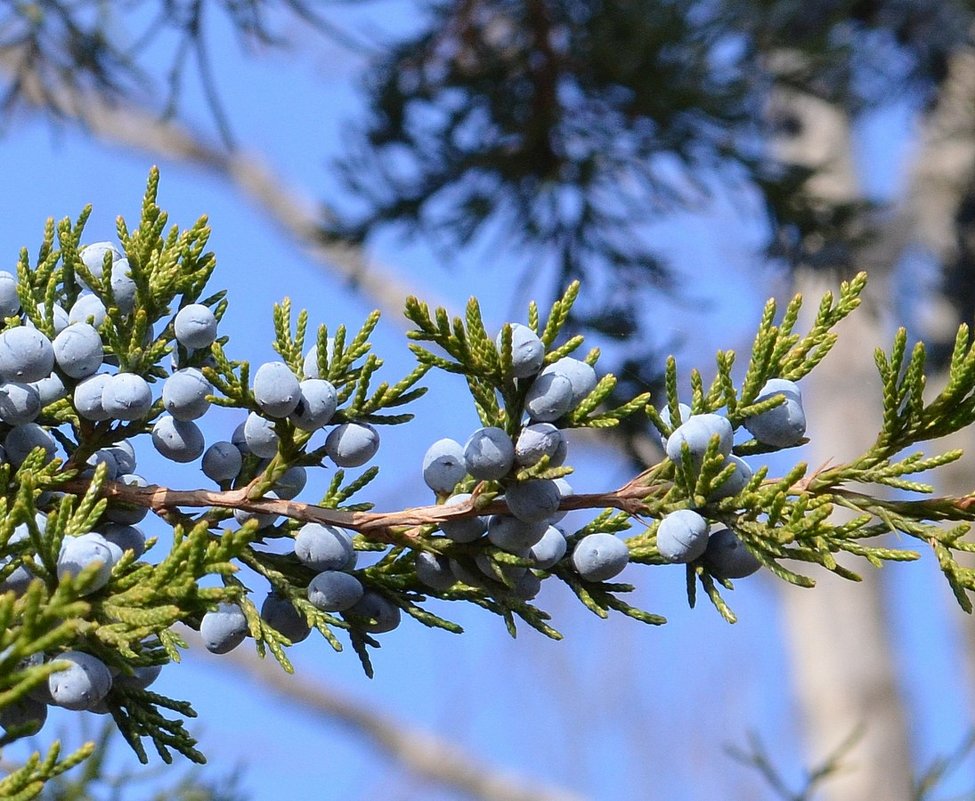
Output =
[{"x1": 772, "y1": 86, "x2": 912, "y2": 801}]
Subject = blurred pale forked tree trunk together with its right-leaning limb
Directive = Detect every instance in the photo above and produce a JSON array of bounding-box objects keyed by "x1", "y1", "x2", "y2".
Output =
[{"x1": 778, "y1": 25, "x2": 975, "y2": 801}]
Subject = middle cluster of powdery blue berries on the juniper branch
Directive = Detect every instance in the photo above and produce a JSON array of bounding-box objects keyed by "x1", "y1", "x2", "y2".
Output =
[{"x1": 416, "y1": 323, "x2": 629, "y2": 600}]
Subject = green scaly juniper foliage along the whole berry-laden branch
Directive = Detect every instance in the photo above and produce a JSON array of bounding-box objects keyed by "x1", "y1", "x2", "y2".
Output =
[{"x1": 9, "y1": 171, "x2": 975, "y2": 798}]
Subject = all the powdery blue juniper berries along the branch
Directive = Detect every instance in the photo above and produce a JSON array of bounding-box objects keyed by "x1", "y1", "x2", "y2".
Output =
[{"x1": 0, "y1": 242, "x2": 805, "y2": 728}]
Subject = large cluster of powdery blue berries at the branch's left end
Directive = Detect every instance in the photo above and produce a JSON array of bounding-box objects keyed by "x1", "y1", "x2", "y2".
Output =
[{"x1": 0, "y1": 242, "x2": 399, "y2": 716}]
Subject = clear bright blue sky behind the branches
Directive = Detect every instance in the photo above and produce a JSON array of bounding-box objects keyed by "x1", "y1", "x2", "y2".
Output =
[{"x1": 0, "y1": 3, "x2": 975, "y2": 801}]
